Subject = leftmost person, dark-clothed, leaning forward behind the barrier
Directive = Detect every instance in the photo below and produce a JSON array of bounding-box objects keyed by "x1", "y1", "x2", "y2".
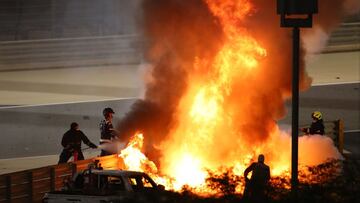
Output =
[{"x1": 58, "y1": 122, "x2": 97, "y2": 164}]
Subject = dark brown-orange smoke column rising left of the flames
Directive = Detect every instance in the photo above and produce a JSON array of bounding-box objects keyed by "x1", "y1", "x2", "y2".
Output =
[{"x1": 119, "y1": 0, "x2": 222, "y2": 161}]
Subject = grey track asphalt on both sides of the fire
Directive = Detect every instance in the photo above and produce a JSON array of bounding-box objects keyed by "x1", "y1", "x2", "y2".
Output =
[{"x1": 0, "y1": 83, "x2": 360, "y2": 159}]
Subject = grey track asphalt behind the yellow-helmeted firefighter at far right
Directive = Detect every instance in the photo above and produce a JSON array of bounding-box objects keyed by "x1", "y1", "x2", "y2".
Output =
[{"x1": 280, "y1": 82, "x2": 360, "y2": 131}]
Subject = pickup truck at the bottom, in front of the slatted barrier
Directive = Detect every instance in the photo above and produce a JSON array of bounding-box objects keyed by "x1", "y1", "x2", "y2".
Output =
[{"x1": 43, "y1": 169, "x2": 169, "y2": 203}]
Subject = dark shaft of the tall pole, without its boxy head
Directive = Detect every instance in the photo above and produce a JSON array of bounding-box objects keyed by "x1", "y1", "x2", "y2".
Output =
[{"x1": 291, "y1": 27, "x2": 300, "y2": 200}]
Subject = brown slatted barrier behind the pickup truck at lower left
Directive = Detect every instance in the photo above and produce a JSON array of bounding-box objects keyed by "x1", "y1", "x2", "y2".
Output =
[{"x1": 0, "y1": 155, "x2": 123, "y2": 203}]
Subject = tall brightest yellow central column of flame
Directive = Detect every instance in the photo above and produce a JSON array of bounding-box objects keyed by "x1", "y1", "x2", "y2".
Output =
[{"x1": 158, "y1": 1, "x2": 266, "y2": 192}]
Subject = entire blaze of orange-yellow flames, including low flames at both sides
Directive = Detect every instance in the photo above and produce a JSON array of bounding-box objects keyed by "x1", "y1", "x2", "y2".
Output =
[{"x1": 119, "y1": 0, "x2": 339, "y2": 194}]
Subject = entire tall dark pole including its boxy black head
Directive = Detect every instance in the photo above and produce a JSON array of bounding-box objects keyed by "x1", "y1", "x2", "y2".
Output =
[{"x1": 277, "y1": 0, "x2": 318, "y2": 202}]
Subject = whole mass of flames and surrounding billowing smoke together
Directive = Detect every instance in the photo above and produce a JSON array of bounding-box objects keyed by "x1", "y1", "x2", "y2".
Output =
[{"x1": 41, "y1": 0, "x2": 356, "y2": 202}]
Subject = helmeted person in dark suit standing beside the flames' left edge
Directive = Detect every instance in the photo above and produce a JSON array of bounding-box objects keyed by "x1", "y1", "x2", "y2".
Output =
[{"x1": 100, "y1": 107, "x2": 117, "y2": 156}]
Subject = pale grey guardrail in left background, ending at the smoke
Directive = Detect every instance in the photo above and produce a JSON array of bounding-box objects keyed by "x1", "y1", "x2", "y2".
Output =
[{"x1": 0, "y1": 35, "x2": 142, "y2": 71}]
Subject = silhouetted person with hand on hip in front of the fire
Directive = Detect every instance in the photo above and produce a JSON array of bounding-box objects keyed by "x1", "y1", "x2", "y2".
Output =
[{"x1": 244, "y1": 154, "x2": 270, "y2": 202}]
